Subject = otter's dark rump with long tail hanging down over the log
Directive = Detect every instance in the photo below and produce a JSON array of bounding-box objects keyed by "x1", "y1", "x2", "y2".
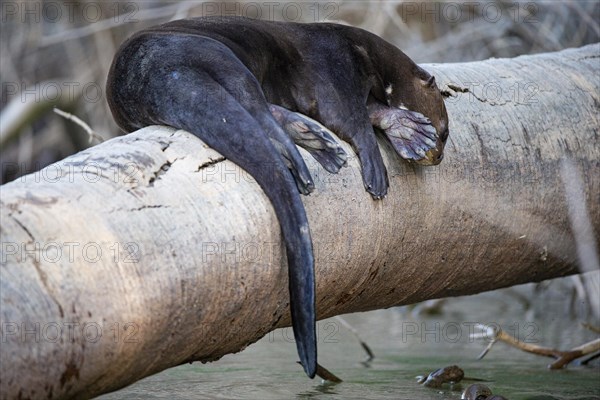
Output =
[{"x1": 108, "y1": 35, "x2": 317, "y2": 378}]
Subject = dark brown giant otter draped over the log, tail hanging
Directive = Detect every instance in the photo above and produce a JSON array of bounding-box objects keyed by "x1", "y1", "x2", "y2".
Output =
[{"x1": 107, "y1": 17, "x2": 448, "y2": 378}]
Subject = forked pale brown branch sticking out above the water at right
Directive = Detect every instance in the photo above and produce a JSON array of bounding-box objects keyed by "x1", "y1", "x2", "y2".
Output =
[{"x1": 473, "y1": 325, "x2": 600, "y2": 369}]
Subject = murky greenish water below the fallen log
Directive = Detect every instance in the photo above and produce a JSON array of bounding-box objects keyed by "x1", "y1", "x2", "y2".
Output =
[{"x1": 101, "y1": 282, "x2": 600, "y2": 400}]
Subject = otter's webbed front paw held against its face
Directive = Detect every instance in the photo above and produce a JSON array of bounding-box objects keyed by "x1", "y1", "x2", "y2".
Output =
[{"x1": 369, "y1": 104, "x2": 438, "y2": 162}]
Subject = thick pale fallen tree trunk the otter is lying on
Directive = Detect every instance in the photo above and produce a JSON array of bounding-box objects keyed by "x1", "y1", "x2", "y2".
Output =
[{"x1": 0, "y1": 45, "x2": 600, "y2": 398}]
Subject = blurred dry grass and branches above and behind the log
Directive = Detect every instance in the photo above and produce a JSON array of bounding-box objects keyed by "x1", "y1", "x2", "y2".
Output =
[{"x1": 0, "y1": 0, "x2": 600, "y2": 183}]
